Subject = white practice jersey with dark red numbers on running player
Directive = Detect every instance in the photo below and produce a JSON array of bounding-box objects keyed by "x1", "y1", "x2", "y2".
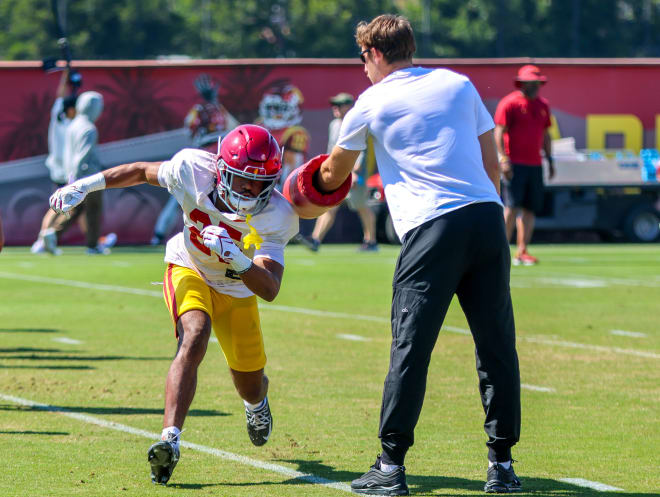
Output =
[{"x1": 158, "y1": 148, "x2": 298, "y2": 297}]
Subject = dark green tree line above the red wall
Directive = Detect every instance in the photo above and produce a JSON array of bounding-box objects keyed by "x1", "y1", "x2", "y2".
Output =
[{"x1": 0, "y1": 0, "x2": 660, "y2": 60}]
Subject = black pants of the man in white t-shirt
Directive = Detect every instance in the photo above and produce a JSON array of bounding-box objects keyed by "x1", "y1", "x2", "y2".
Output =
[{"x1": 379, "y1": 202, "x2": 520, "y2": 464}]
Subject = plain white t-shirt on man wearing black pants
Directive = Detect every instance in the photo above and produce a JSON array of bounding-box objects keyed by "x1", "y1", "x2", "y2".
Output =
[{"x1": 337, "y1": 67, "x2": 502, "y2": 238}]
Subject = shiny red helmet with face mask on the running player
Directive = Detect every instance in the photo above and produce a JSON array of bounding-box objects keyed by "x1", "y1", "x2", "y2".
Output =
[{"x1": 216, "y1": 124, "x2": 282, "y2": 216}]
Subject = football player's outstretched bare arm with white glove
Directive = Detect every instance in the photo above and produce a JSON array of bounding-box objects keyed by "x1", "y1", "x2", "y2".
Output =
[{"x1": 50, "y1": 162, "x2": 162, "y2": 214}]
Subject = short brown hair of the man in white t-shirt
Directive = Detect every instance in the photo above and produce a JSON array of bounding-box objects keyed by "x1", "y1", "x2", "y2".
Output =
[{"x1": 355, "y1": 14, "x2": 417, "y2": 64}]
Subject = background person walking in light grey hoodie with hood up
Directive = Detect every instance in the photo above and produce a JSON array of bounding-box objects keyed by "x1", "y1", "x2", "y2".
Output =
[{"x1": 53, "y1": 91, "x2": 117, "y2": 255}]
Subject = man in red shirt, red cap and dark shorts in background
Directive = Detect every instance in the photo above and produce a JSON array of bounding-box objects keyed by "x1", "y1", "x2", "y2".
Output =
[{"x1": 495, "y1": 65, "x2": 555, "y2": 266}]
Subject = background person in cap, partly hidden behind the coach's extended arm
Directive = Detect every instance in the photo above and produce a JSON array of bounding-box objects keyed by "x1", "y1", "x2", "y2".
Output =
[{"x1": 298, "y1": 93, "x2": 378, "y2": 252}]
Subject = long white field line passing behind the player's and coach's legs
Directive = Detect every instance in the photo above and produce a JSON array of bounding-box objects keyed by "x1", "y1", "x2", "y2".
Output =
[{"x1": 0, "y1": 271, "x2": 660, "y2": 359}]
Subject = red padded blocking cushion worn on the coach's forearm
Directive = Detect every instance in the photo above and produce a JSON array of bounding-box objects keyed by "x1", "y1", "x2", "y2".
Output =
[{"x1": 282, "y1": 154, "x2": 351, "y2": 219}]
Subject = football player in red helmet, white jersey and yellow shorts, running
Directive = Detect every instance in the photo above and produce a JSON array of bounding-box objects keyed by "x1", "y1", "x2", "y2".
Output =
[{"x1": 50, "y1": 125, "x2": 298, "y2": 485}]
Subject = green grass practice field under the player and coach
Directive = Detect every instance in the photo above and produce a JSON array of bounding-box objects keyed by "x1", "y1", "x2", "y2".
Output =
[{"x1": 0, "y1": 245, "x2": 660, "y2": 497}]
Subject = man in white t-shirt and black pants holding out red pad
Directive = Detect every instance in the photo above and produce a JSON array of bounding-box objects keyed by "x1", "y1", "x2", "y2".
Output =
[{"x1": 316, "y1": 15, "x2": 521, "y2": 495}]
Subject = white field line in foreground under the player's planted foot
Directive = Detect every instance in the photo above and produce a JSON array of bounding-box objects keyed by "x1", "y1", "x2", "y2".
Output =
[{"x1": 0, "y1": 393, "x2": 351, "y2": 492}]
